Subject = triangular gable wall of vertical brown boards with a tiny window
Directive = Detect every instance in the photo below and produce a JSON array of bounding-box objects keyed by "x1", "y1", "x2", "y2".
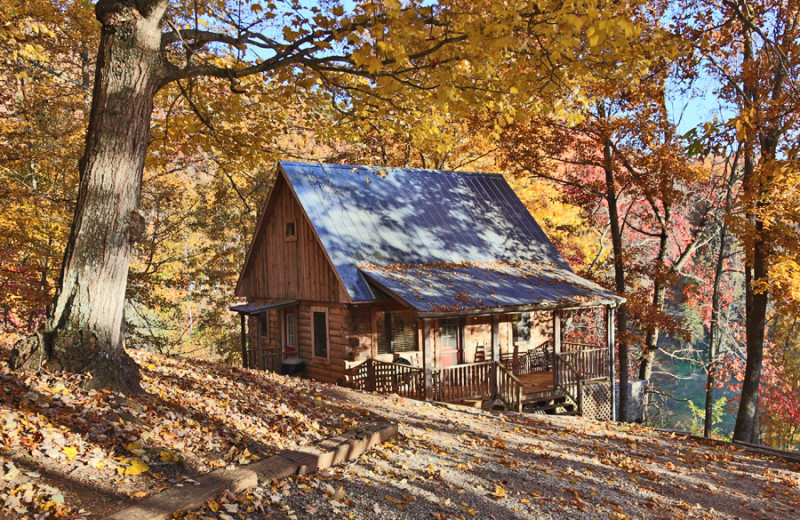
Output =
[{"x1": 238, "y1": 174, "x2": 349, "y2": 302}]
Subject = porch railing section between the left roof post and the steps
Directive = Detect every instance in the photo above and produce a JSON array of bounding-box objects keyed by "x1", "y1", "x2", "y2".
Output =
[{"x1": 431, "y1": 361, "x2": 497, "y2": 402}]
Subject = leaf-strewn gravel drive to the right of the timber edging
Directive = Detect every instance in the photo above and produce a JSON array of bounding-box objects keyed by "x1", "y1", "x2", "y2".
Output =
[{"x1": 178, "y1": 386, "x2": 800, "y2": 520}]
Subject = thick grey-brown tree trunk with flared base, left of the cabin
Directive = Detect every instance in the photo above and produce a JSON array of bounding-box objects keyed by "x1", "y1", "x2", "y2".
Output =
[{"x1": 11, "y1": 0, "x2": 168, "y2": 392}]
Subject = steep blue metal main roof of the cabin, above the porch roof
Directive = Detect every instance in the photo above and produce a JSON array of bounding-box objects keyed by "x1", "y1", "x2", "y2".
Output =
[{"x1": 280, "y1": 162, "x2": 620, "y2": 309}]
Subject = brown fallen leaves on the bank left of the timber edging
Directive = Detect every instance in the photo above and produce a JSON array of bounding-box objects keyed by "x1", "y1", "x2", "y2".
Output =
[{"x1": 0, "y1": 346, "x2": 364, "y2": 520}]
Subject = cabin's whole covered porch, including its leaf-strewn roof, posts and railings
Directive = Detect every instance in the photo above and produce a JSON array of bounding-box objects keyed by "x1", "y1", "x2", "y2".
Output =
[{"x1": 349, "y1": 263, "x2": 624, "y2": 419}]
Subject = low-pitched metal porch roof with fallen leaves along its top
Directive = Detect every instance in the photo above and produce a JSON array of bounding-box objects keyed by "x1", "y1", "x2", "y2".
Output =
[{"x1": 360, "y1": 262, "x2": 625, "y2": 317}]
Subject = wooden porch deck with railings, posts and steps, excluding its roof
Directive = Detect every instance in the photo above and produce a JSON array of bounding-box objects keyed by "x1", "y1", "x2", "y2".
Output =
[{"x1": 346, "y1": 307, "x2": 615, "y2": 420}]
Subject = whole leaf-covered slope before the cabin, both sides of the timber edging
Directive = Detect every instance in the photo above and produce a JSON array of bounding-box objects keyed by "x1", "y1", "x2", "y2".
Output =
[{"x1": 0, "y1": 351, "x2": 800, "y2": 520}]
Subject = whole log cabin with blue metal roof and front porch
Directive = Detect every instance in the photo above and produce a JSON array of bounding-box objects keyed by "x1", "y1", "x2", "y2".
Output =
[{"x1": 231, "y1": 162, "x2": 624, "y2": 419}]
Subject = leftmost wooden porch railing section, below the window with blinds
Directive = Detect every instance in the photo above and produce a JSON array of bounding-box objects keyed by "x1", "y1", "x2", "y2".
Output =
[{"x1": 346, "y1": 359, "x2": 425, "y2": 400}]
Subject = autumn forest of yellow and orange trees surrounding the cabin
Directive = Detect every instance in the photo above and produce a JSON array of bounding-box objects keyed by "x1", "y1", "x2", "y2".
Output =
[{"x1": 0, "y1": 0, "x2": 800, "y2": 451}]
